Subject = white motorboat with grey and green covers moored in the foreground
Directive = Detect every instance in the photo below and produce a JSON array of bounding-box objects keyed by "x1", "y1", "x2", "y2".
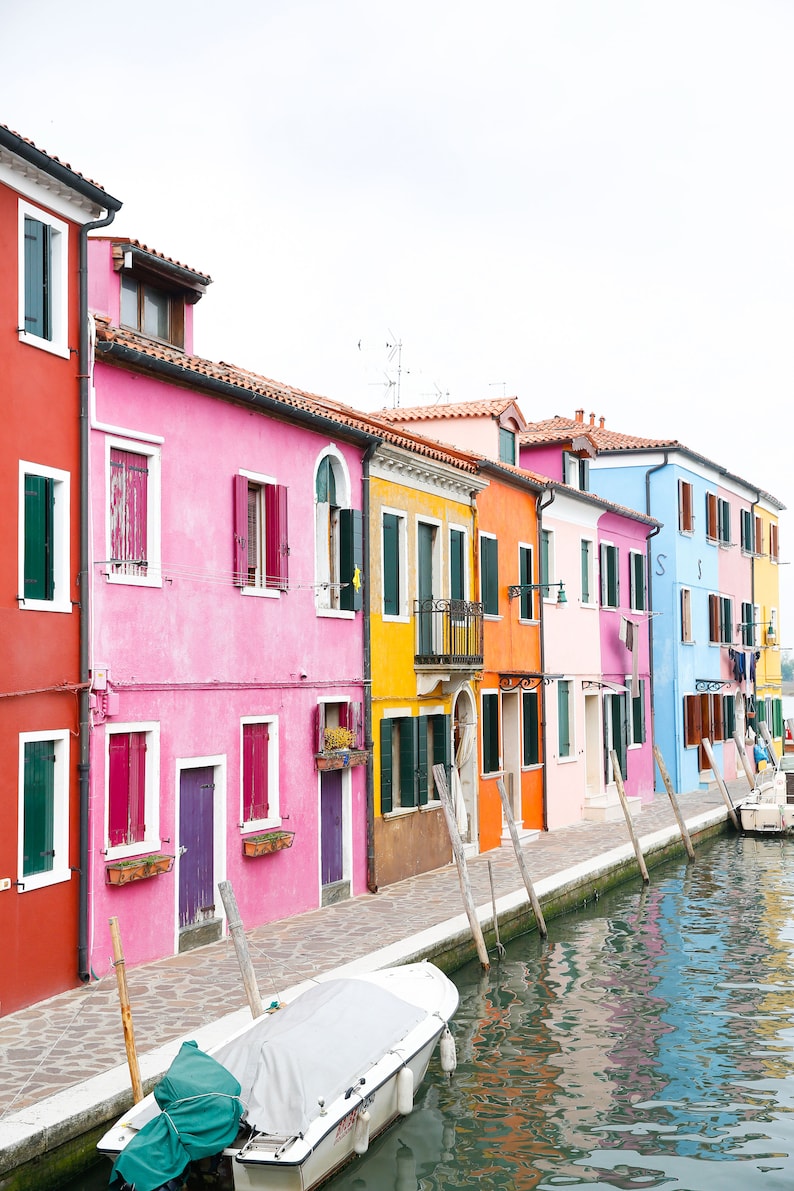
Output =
[{"x1": 98, "y1": 961, "x2": 458, "y2": 1191}]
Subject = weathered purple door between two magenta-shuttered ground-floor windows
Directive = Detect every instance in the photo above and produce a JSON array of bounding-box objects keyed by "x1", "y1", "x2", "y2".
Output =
[{"x1": 180, "y1": 766, "x2": 215, "y2": 928}]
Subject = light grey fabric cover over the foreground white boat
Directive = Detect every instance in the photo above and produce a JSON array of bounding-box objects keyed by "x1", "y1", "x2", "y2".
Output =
[{"x1": 213, "y1": 980, "x2": 428, "y2": 1137}]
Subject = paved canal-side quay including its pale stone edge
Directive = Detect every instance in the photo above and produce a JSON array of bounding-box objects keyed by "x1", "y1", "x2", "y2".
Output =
[{"x1": 0, "y1": 782, "x2": 748, "y2": 1185}]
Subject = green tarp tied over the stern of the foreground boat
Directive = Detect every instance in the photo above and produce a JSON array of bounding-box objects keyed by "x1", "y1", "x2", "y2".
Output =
[{"x1": 110, "y1": 1042, "x2": 243, "y2": 1191}]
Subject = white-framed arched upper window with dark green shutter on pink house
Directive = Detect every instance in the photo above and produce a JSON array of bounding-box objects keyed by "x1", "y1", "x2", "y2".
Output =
[{"x1": 314, "y1": 449, "x2": 363, "y2": 612}]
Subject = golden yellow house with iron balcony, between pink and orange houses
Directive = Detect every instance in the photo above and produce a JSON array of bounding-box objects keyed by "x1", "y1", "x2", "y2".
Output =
[{"x1": 368, "y1": 434, "x2": 484, "y2": 886}]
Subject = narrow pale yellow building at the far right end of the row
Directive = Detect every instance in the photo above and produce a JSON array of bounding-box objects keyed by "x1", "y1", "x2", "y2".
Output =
[{"x1": 742, "y1": 493, "x2": 783, "y2": 754}]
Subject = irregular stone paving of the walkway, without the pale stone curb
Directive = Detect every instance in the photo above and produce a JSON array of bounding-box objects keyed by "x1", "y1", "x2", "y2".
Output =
[{"x1": 0, "y1": 784, "x2": 746, "y2": 1131}]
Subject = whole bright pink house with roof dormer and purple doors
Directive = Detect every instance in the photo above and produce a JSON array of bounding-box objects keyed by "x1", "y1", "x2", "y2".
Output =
[{"x1": 89, "y1": 239, "x2": 378, "y2": 974}]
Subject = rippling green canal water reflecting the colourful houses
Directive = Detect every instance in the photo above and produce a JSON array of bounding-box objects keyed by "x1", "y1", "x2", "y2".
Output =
[{"x1": 74, "y1": 836, "x2": 794, "y2": 1191}]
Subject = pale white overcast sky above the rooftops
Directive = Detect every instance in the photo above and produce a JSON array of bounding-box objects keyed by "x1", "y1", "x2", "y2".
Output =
[{"x1": 0, "y1": 0, "x2": 794, "y2": 647}]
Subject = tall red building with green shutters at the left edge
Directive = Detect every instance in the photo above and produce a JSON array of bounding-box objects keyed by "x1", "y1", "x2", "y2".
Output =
[{"x1": 0, "y1": 126, "x2": 120, "y2": 1015}]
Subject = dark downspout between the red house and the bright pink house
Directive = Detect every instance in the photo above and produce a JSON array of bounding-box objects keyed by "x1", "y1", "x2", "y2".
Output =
[{"x1": 77, "y1": 209, "x2": 121, "y2": 984}]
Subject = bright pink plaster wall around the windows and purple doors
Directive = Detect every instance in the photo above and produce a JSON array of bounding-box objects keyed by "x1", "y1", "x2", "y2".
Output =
[{"x1": 90, "y1": 360, "x2": 367, "y2": 966}]
